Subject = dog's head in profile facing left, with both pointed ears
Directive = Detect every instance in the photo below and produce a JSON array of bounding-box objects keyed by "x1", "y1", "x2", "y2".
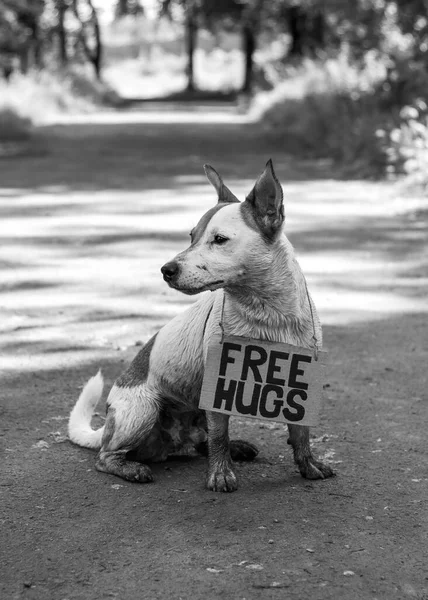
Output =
[{"x1": 161, "y1": 160, "x2": 284, "y2": 294}]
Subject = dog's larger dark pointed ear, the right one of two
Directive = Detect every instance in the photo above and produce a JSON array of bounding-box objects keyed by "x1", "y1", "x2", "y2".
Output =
[{"x1": 244, "y1": 159, "x2": 284, "y2": 240}]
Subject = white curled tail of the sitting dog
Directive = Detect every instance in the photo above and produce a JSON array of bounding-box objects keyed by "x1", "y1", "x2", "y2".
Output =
[{"x1": 68, "y1": 371, "x2": 104, "y2": 449}]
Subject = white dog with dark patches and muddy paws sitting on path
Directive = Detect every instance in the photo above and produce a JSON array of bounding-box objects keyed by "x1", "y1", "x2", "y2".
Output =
[{"x1": 69, "y1": 160, "x2": 334, "y2": 492}]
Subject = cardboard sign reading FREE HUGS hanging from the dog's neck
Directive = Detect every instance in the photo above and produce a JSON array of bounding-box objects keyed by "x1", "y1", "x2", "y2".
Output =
[{"x1": 199, "y1": 335, "x2": 327, "y2": 425}]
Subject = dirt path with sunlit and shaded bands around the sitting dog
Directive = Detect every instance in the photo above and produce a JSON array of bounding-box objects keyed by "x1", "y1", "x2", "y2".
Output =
[{"x1": 0, "y1": 112, "x2": 428, "y2": 600}]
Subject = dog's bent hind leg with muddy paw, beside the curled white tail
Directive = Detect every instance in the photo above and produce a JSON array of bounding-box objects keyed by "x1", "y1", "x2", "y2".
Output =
[{"x1": 95, "y1": 386, "x2": 160, "y2": 483}]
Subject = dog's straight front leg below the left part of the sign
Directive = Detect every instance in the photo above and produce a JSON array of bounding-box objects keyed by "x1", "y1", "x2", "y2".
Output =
[{"x1": 206, "y1": 411, "x2": 238, "y2": 492}]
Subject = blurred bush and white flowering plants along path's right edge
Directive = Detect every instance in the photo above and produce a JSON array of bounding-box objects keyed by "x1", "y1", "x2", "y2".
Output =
[{"x1": 253, "y1": 52, "x2": 428, "y2": 187}]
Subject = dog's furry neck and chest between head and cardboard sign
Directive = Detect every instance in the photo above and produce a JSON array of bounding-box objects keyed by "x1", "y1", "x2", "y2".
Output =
[{"x1": 223, "y1": 238, "x2": 315, "y2": 346}]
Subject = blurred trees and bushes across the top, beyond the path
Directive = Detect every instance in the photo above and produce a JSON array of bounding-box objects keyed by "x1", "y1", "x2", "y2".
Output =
[{"x1": 0, "y1": 0, "x2": 428, "y2": 187}]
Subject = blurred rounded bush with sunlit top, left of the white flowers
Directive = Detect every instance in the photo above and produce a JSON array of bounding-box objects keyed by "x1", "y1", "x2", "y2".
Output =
[{"x1": 256, "y1": 52, "x2": 387, "y2": 176}]
